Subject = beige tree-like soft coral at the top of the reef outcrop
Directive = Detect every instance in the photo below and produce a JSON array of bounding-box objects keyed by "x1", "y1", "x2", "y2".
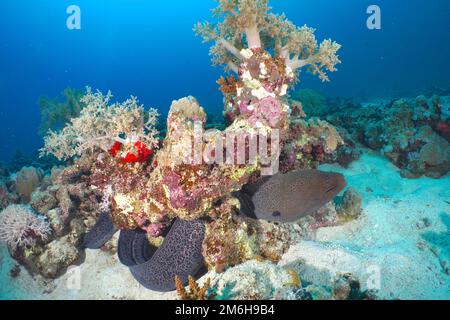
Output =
[{"x1": 194, "y1": 0, "x2": 341, "y2": 81}]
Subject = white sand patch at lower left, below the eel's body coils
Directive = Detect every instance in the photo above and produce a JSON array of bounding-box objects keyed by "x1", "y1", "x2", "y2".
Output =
[{"x1": 0, "y1": 232, "x2": 176, "y2": 300}]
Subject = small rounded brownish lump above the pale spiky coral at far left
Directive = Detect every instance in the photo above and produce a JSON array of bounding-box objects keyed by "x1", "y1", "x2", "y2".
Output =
[{"x1": 10, "y1": 167, "x2": 44, "y2": 203}]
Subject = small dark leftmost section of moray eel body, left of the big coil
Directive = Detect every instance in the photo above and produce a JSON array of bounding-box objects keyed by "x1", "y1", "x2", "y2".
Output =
[{"x1": 82, "y1": 212, "x2": 117, "y2": 249}]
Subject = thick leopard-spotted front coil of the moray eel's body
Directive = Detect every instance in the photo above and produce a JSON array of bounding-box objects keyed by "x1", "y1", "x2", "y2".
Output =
[{"x1": 130, "y1": 219, "x2": 205, "y2": 292}]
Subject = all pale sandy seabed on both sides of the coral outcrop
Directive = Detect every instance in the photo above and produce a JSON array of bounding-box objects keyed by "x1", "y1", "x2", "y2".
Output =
[{"x1": 0, "y1": 150, "x2": 450, "y2": 299}]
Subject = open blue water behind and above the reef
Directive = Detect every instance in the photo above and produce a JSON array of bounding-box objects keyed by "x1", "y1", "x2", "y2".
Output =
[{"x1": 0, "y1": 0, "x2": 450, "y2": 161}]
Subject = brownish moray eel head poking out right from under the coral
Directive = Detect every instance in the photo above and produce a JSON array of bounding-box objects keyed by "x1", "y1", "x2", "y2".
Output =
[{"x1": 234, "y1": 170, "x2": 347, "y2": 223}]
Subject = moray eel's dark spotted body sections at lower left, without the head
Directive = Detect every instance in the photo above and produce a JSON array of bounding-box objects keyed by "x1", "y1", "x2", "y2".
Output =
[{"x1": 83, "y1": 213, "x2": 205, "y2": 292}]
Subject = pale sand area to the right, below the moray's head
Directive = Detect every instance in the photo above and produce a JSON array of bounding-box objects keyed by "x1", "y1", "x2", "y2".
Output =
[{"x1": 282, "y1": 151, "x2": 450, "y2": 299}]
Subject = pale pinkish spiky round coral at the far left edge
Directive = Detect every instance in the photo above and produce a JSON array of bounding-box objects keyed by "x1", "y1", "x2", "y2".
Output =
[{"x1": 0, "y1": 205, "x2": 51, "y2": 252}]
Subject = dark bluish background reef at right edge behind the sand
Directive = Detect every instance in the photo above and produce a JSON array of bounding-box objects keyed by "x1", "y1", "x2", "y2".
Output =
[{"x1": 327, "y1": 95, "x2": 450, "y2": 178}]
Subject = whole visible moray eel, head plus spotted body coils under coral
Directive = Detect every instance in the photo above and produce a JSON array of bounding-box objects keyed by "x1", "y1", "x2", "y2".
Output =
[{"x1": 83, "y1": 170, "x2": 347, "y2": 292}]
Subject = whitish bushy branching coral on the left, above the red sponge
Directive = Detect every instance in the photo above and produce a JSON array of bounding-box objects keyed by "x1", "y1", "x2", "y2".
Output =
[{"x1": 41, "y1": 88, "x2": 158, "y2": 160}]
